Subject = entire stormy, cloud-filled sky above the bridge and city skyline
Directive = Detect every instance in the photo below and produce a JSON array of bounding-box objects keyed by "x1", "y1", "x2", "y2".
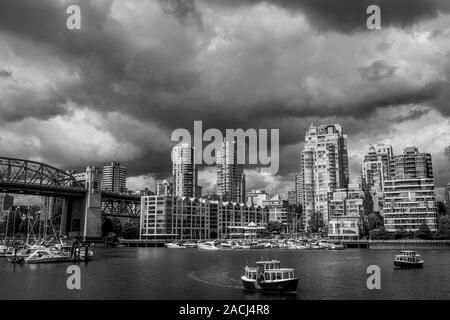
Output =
[{"x1": 0, "y1": 0, "x2": 450, "y2": 202}]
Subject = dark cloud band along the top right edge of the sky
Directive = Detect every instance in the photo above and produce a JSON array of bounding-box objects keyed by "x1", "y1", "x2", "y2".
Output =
[{"x1": 207, "y1": 0, "x2": 450, "y2": 32}]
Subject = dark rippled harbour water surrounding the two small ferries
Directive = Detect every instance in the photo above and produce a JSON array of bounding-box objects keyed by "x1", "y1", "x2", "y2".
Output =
[{"x1": 0, "y1": 248, "x2": 450, "y2": 300}]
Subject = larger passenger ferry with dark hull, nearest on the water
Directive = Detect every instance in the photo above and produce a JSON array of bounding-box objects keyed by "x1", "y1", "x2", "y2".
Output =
[{"x1": 241, "y1": 260, "x2": 298, "y2": 293}]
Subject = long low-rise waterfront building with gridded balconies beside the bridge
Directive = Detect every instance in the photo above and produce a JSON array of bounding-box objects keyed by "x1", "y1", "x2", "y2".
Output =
[{"x1": 140, "y1": 196, "x2": 269, "y2": 240}]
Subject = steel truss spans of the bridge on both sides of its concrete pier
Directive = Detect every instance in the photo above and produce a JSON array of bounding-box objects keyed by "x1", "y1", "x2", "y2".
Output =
[{"x1": 0, "y1": 157, "x2": 141, "y2": 218}]
